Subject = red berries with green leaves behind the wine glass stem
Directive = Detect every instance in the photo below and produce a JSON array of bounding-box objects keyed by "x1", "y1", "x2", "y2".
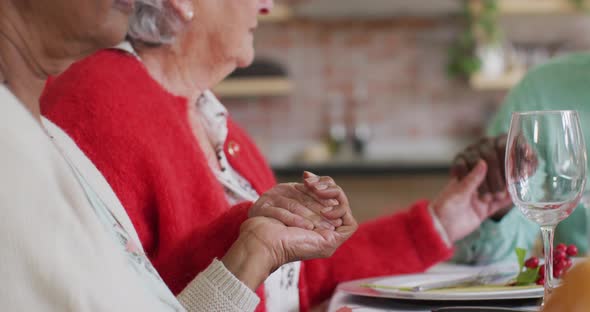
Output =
[{"x1": 513, "y1": 244, "x2": 578, "y2": 286}]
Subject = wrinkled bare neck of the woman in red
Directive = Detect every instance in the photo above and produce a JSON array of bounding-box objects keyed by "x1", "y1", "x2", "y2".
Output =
[{"x1": 135, "y1": 38, "x2": 234, "y2": 103}]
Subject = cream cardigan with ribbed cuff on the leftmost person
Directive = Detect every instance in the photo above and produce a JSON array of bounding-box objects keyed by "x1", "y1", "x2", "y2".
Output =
[{"x1": 0, "y1": 85, "x2": 259, "y2": 312}]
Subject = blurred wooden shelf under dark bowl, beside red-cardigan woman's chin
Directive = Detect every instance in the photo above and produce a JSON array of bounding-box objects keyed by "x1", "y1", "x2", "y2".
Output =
[{"x1": 213, "y1": 77, "x2": 293, "y2": 97}]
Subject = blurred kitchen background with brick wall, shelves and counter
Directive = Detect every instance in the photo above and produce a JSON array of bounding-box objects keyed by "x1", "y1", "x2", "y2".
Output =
[{"x1": 215, "y1": 0, "x2": 590, "y2": 221}]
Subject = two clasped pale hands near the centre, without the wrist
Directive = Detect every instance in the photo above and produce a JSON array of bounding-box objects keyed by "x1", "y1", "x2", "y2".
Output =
[{"x1": 240, "y1": 172, "x2": 358, "y2": 270}]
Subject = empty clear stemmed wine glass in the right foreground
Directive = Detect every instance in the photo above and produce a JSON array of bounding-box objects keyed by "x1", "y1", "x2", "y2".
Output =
[{"x1": 506, "y1": 111, "x2": 587, "y2": 300}]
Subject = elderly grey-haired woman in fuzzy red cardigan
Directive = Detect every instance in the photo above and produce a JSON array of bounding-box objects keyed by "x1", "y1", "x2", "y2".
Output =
[{"x1": 41, "y1": 0, "x2": 512, "y2": 311}]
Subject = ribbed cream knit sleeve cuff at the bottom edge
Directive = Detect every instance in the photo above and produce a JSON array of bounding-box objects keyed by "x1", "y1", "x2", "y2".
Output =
[{"x1": 178, "y1": 259, "x2": 260, "y2": 312}]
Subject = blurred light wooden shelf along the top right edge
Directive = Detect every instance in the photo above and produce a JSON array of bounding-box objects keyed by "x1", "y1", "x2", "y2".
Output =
[{"x1": 498, "y1": 0, "x2": 590, "y2": 14}]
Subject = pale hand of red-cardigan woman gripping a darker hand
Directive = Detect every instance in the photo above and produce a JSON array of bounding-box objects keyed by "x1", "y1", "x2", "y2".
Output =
[{"x1": 431, "y1": 160, "x2": 512, "y2": 242}]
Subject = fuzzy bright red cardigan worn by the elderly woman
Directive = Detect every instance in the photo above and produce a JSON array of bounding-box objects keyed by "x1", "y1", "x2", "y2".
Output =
[{"x1": 41, "y1": 50, "x2": 452, "y2": 310}]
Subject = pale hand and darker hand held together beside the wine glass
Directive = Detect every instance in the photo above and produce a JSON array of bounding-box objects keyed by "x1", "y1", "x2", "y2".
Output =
[{"x1": 431, "y1": 134, "x2": 538, "y2": 242}]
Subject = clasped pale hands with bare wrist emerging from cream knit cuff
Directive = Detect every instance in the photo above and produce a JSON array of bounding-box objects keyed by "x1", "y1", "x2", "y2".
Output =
[{"x1": 222, "y1": 173, "x2": 358, "y2": 290}]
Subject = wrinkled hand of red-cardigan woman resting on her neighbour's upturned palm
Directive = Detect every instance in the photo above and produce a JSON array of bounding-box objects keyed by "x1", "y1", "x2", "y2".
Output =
[{"x1": 248, "y1": 172, "x2": 350, "y2": 230}]
